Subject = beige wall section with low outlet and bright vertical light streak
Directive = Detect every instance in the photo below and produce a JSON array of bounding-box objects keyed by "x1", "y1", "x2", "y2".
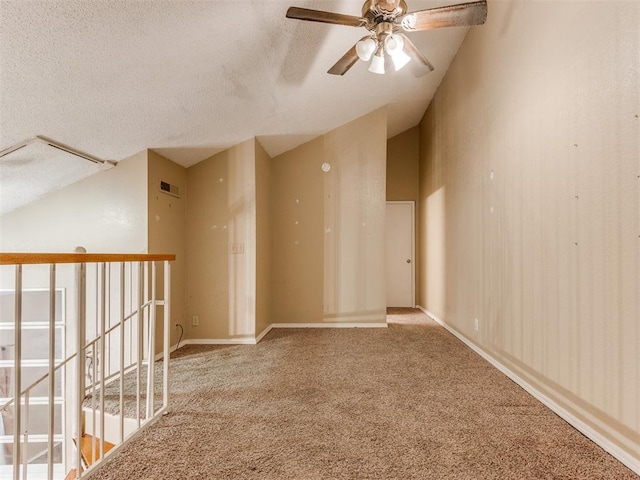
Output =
[{"x1": 186, "y1": 139, "x2": 256, "y2": 339}]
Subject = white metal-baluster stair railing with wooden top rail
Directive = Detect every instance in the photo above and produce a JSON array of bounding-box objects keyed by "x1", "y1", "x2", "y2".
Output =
[{"x1": 0, "y1": 253, "x2": 175, "y2": 480}]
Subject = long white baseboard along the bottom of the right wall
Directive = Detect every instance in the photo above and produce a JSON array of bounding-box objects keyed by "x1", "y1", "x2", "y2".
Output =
[{"x1": 417, "y1": 305, "x2": 640, "y2": 475}]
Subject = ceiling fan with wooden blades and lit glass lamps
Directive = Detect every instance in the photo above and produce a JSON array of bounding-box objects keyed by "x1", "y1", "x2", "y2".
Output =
[{"x1": 287, "y1": 0, "x2": 487, "y2": 77}]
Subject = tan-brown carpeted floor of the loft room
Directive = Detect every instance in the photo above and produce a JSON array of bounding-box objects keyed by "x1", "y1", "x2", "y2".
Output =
[{"x1": 92, "y1": 310, "x2": 638, "y2": 480}]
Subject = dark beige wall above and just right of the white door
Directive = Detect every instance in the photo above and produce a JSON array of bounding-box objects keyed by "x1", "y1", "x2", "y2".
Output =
[{"x1": 387, "y1": 126, "x2": 420, "y2": 298}]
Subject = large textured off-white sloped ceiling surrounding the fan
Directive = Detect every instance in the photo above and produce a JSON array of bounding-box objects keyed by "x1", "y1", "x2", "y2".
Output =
[{"x1": 0, "y1": 0, "x2": 467, "y2": 172}]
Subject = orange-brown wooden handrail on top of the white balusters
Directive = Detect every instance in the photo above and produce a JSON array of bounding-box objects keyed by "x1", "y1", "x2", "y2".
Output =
[{"x1": 0, "y1": 253, "x2": 176, "y2": 265}]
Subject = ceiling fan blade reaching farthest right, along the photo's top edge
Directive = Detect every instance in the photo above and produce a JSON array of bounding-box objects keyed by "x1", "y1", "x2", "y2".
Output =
[{"x1": 396, "y1": 0, "x2": 487, "y2": 32}]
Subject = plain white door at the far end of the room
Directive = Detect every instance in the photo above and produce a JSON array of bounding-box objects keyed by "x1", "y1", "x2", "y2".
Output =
[{"x1": 386, "y1": 202, "x2": 415, "y2": 307}]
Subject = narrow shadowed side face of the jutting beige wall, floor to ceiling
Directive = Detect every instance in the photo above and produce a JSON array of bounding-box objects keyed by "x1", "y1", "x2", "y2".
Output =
[{"x1": 255, "y1": 140, "x2": 272, "y2": 335}]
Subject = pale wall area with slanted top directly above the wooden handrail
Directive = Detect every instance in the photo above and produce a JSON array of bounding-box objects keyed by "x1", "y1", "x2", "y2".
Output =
[{"x1": 0, "y1": 151, "x2": 147, "y2": 253}]
